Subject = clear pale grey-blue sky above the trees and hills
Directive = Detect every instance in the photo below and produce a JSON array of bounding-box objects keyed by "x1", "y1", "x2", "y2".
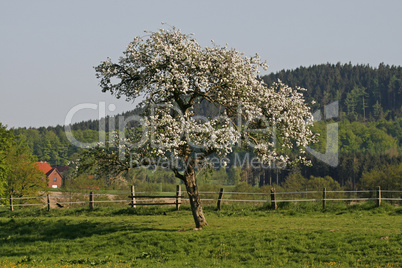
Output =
[{"x1": 0, "y1": 0, "x2": 402, "y2": 127}]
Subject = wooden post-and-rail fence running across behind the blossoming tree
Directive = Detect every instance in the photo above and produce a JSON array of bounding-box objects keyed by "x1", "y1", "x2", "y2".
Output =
[{"x1": 0, "y1": 185, "x2": 402, "y2": 211}]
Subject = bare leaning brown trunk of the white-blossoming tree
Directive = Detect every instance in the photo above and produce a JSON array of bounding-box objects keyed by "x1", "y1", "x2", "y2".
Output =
[{"x1": 184, "y1": 167, "x2": 208, "y2": 228}]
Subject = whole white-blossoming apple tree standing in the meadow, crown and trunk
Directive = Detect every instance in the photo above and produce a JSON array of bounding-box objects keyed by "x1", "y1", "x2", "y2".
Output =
[{"x1": 75, "y1": 27, "x2": 313, "y2": 228}]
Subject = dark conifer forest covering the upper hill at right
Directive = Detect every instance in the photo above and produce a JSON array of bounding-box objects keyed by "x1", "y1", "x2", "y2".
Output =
[{"x1": 262, "y1": 63, "x2": 402, "y2": 122}]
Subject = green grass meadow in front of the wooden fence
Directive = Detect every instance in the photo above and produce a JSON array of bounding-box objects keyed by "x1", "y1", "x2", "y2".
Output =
[{"x1": 0, "y1": 203, "x2": 402, "y2": 267}]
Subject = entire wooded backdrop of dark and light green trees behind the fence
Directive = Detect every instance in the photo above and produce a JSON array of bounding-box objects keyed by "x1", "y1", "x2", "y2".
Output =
[{"x1": 3, "y1": 63, "x2": 402, "y2": 195}]
